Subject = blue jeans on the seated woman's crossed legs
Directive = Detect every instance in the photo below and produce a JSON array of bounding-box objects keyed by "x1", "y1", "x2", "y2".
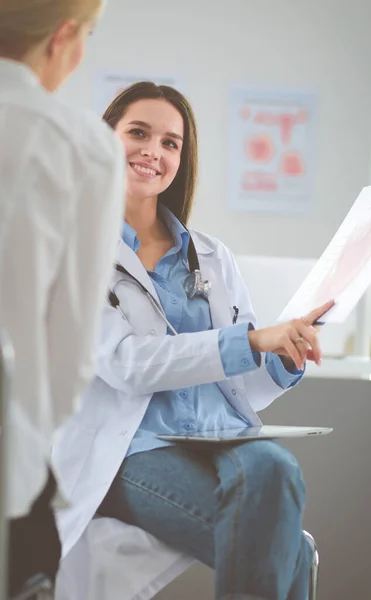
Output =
[{"x1": 99, "y1": 440, "x2": 312, "y2": 600}]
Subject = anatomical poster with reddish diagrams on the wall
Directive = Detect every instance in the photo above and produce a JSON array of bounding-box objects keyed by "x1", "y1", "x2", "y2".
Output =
[{"x1": 228, "y1": 85, "x2": 316, "y2": 214}]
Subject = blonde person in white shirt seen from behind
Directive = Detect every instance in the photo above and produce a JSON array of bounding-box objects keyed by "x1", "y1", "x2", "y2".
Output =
[{"x1": 0, "y1": 0, "x2": 124, "y2": 594}]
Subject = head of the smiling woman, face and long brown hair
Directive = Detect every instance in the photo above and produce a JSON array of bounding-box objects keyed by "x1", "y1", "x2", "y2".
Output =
[{"x1": 103, "y1": 82, "x2": 198, "y2": 224}]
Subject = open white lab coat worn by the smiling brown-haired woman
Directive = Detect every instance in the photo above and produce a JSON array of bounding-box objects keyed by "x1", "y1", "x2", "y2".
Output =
[{"x1": 53, "y1": 232, "x2": 292, "y2": 600}]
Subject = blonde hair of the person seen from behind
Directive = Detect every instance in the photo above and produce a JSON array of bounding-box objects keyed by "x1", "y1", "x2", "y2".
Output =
[{"x1": 0, "y1": 0, "x2": 102, "y2": 60}]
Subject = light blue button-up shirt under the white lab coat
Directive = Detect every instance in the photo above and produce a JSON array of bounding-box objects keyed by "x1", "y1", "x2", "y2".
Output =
[{"x1": 123, "y1": 208, "x2": 302, "y2": 456}]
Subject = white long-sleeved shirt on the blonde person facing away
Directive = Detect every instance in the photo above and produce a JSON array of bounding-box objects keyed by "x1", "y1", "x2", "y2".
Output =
[{"x1": 0, "y1": 59, "x2": 124, "y2": 517}]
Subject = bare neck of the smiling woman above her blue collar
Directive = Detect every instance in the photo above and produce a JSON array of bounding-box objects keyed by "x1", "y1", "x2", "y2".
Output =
[{"x1": 125, "y1": 196, "x2": 162, "y2": 243}]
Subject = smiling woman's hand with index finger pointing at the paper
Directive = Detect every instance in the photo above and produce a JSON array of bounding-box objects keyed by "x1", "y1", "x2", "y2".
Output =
[{"x1": 248, "y1": 300, "x2": 334, "y2": 370}]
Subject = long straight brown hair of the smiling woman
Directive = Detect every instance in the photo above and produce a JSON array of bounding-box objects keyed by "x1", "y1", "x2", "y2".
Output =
[{"x1": 103, "y1": 81, "x2": 198, "y2": 225}]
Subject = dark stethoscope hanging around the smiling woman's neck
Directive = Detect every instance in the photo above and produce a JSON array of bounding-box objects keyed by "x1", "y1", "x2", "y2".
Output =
[{"x1": 108, "y1": 235, "x2": 211, "y2": 335}]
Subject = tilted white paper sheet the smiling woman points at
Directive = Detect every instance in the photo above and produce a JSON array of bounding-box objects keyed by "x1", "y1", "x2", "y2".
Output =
[{"x1": 278, "y1": 186, "x2": 371, "y2": 323}]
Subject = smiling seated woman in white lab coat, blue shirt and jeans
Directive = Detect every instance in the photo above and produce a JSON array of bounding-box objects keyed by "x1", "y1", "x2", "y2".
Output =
[{"x1": 54, "y1": 83, "x2": 331, "y2": 600}]
